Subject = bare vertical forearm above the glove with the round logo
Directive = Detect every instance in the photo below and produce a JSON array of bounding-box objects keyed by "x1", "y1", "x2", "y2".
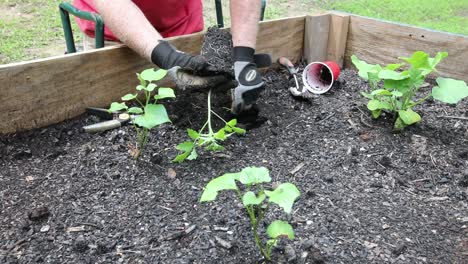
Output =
[{"x1": 231, "y1": 0, "x2": 262, "y2": 49}]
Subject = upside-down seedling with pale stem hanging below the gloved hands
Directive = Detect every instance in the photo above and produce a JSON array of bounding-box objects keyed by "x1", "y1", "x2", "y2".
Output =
[{"x1": 173, "y1": 90, "x2": 245, "y2": 162}]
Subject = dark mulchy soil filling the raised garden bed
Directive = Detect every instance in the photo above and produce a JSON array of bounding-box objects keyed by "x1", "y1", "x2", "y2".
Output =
[{"x1": 0, "y1": 66, "x2": 468, "y2": 263}]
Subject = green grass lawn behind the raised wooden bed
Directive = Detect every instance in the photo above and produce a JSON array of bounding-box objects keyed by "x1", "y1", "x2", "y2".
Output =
[{"x1": 0, "y1": 0, "x2": 468, "y2": 64}]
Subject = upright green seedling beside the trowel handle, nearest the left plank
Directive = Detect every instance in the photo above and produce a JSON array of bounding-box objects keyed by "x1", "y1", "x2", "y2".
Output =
[{"x1": 109, "y1": 69, "x2": 175, "y2": 159}]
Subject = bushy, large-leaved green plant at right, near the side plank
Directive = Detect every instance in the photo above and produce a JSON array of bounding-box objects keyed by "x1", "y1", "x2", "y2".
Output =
[{"x1": 351, "y1": 51, "x2": 468, "y2": 131}]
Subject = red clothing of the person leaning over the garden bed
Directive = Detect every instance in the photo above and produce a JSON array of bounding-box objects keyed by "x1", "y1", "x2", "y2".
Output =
[{"x1": 73, "y1": 0, "x2": 203, "y2": 40}]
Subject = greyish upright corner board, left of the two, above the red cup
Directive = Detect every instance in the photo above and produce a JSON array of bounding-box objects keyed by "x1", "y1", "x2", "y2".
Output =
[{"x1": 304, "y1": 14, "x2": 331, "y2": 63}]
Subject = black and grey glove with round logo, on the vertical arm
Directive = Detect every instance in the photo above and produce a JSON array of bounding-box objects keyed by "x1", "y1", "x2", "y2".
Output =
[{"x1": 231, "y1": 47, "x2": 271, "y2": 115}]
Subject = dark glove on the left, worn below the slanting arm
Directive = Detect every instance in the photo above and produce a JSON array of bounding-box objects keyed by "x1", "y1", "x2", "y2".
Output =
[{"x1": 151, "y1": 40, "x2": 230, "y2": 89}]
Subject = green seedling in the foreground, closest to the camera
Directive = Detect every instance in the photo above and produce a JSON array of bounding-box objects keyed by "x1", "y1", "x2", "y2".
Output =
[{"x1": 200, "y1": 167, "x2": 300, "y2": 261}]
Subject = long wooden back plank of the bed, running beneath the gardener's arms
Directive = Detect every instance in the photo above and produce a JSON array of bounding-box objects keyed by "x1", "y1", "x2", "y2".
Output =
[{"x1": 0, "y1": 17, "x2": 305, "y2": 134}]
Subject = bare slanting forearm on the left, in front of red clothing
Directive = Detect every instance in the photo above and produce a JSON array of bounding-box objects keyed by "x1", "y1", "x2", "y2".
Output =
[{"x1": 94, "y1": 0, "x2": 162, "y2": 60}]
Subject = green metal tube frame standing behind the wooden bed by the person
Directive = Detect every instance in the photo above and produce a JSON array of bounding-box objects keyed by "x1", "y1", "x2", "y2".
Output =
[{"x1": 59, "y1": 0, "x2": 266, "y2": 53}]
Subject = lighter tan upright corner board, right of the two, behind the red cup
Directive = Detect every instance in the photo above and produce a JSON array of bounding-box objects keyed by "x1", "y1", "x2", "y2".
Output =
[{"x1": 327, "y1": 13, "x2": 349, "y2": 68}]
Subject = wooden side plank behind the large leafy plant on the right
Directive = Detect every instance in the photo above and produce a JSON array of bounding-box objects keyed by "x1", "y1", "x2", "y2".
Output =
[{"x1": 345, "y1": 15, "x2": 468, "y2": 81}]
